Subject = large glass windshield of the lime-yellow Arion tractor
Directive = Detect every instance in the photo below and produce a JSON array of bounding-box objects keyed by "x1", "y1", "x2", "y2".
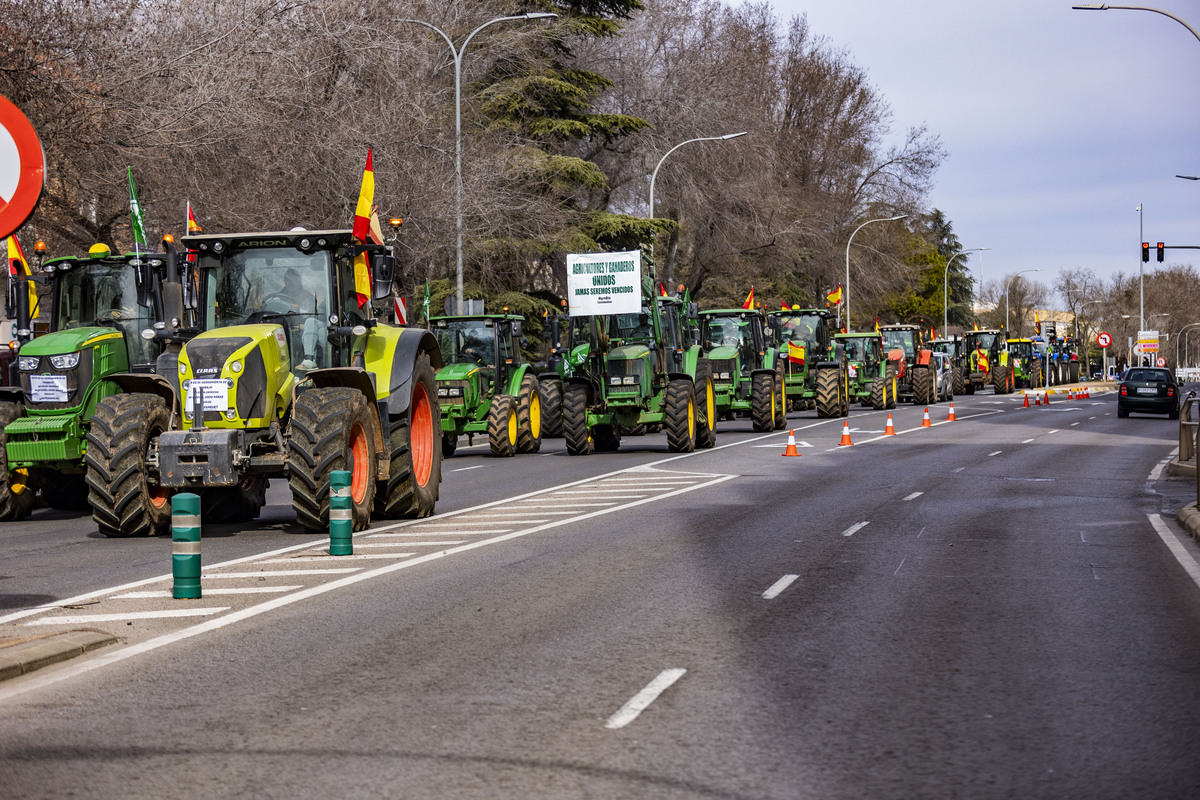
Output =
[{"x1": 199, "y1": 247, "x2": 331, "y2": 369}]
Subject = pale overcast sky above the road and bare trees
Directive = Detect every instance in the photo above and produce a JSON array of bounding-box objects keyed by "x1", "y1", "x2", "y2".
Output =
[{"x1": 758, "y1": 0, "x2": 1200, "y2": 304}]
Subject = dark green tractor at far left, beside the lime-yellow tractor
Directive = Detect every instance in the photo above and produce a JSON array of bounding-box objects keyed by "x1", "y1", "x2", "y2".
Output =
[{"x1": 0, "y1": 237, "x2": 176, "y2": 519}]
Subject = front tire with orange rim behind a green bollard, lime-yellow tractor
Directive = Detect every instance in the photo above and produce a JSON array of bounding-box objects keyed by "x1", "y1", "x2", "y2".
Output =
[{"x1": 288, "y1": 386, "x2": 376, "y2": 533}]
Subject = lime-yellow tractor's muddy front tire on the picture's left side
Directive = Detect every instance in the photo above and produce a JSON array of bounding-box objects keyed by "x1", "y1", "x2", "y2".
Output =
[{"x1": 86, "y1": 393, "x2": 170, "y2": 537}]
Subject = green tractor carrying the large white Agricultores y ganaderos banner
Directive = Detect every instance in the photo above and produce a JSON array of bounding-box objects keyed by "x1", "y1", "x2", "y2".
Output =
[{"x1": 563, "y1": 289, "x2": 716, "y2": 456}]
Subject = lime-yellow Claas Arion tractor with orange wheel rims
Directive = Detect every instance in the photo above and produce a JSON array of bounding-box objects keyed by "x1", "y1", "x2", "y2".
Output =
[{"x1": 88, "y1": 230, "x2": 442, "y2": 536}]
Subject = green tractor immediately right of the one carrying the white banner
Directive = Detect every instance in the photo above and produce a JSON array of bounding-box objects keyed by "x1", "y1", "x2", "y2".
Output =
[{"x1": 697, "y1": 308, "x2": 787, "y2": 432}]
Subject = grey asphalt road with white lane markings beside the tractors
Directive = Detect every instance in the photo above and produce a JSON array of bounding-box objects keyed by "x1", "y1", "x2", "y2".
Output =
[{"x1": 0, "y1": 383, "x2": 1200, "y2": 798}]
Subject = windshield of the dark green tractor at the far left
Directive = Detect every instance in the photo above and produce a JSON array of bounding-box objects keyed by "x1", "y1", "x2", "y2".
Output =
[{"x1": 53, "y1": 261, "x2": 154, "y2": 365}]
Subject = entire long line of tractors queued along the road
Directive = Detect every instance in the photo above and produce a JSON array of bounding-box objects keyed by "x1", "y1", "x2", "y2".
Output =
[{"x1": 0, "y1": 229, "x2": 1079, "y2": 536}]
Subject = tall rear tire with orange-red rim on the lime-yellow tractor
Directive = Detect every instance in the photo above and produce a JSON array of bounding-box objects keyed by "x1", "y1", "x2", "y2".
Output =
[{"x1": 374, "y1": 354, "x2": 441, "y2": 519}]
